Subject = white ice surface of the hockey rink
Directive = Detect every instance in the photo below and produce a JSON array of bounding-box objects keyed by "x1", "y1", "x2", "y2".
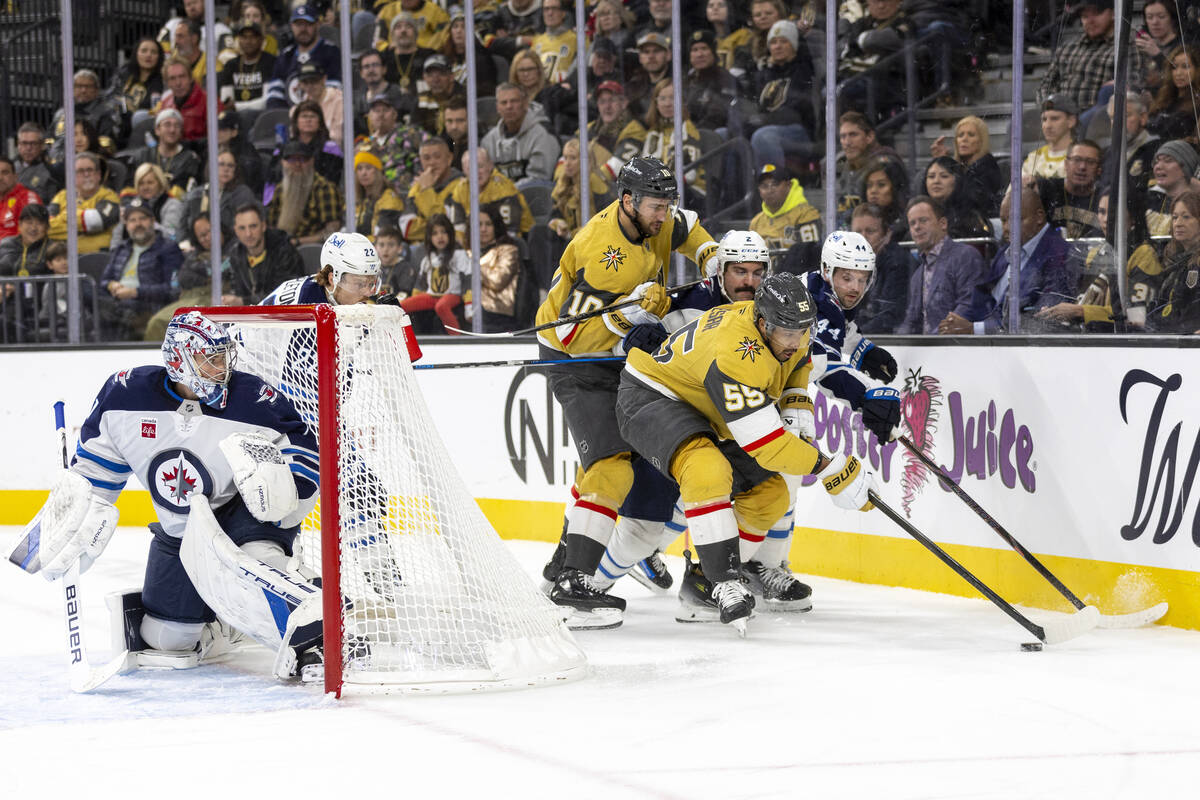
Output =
[{"x1": 0, "y1": 528, "x2": 1200, "y2": 800}]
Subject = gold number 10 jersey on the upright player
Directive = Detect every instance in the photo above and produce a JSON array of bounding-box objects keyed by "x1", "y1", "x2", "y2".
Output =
[{"x1": 538, "y1": 200, "x2": 716, "y2": 356}]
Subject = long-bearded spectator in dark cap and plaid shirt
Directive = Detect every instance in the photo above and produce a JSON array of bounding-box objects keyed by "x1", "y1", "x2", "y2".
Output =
[{"x1": 266, "y1": 140, "x2": 344, "y2": 245}]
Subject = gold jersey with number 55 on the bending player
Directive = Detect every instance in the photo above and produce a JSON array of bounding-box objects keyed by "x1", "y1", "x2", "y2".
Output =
[{"x1": 625, "y1": 300, "x2": 817, "y2": 475}]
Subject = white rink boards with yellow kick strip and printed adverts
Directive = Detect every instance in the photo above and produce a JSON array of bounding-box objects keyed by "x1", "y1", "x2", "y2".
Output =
[{"x1": 0, "y1": 341, "x2": 1200, "y2": 628}]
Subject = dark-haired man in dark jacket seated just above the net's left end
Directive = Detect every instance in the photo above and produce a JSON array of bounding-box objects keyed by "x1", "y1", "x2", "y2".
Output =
[{"x1": 221, "y1": 204, "x2": 307, "y2": 306}]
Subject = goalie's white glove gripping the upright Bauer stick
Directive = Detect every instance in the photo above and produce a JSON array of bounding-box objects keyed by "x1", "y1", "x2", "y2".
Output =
[{"x1": 30, "y1": 470, "x2": 118, "y2": 581}]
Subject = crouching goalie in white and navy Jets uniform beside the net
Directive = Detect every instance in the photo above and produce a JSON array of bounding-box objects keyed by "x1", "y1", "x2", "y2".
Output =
[{"x1": 26, "y1": 311, "x2": 322, "y2": 676}]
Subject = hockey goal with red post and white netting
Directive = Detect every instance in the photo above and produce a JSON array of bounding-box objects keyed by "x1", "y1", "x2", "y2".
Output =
[{"x1": 193, "y1": 305, "x2": 586, "y2": 694}]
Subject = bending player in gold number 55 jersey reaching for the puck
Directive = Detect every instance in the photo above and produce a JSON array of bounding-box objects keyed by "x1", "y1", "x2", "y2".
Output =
[{"x1": 617, "y1": 272, "x2": 875, "y2": 636}]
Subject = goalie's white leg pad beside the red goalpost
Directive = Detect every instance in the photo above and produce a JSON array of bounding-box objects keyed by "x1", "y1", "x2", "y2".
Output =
[{"x1": 179, "y1": 495, "x2": 320, "y2": 650}]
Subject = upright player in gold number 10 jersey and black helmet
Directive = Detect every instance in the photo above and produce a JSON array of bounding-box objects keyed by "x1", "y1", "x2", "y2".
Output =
[{"x1": 538, "y1": 157, "x2": 716, "y2": 628}]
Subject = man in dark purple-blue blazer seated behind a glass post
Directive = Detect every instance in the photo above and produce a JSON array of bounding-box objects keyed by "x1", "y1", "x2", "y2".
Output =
[{"x1": 937, "y1": 186, "x2": 1076, "y2": 336}]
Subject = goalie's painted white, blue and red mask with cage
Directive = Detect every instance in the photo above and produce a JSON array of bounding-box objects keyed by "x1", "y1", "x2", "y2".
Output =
[{"x1": 162, "y1": 311, "x2": 238, "y2": 409}]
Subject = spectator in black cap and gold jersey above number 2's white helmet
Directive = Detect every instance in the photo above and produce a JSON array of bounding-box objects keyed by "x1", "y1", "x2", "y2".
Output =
[{"x1": 750, "y1": 164, "x2": 822, "y2": 275}]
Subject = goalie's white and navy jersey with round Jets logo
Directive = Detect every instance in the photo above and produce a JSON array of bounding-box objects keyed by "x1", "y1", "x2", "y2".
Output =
[{"x1": 71, "y1": 366, "x2": 319, "y2": 536}]
